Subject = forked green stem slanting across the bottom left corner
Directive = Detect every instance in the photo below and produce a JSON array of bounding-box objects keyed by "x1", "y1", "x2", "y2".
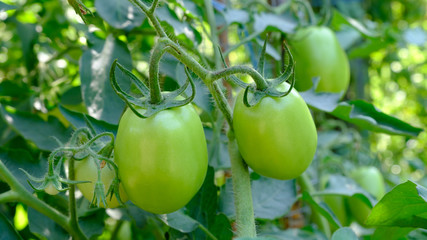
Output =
[{"x1": 0, "y1": 161, "x2": 87, "y2": 240}]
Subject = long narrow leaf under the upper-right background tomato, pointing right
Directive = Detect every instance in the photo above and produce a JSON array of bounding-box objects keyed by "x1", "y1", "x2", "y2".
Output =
[{"x1": 300, "y1": 84, "x2": 423, "y2": 137}]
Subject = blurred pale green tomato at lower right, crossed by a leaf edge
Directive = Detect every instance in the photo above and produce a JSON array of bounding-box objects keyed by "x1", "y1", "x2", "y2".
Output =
[{"x1": 348, "y1": 166, "x2": 385, "y2": 225}]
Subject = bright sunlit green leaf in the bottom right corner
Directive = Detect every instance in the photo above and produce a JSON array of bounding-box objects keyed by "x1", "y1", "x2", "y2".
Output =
[{"x1": 366, "y1": 181, "x2": 427, "y2": 229}]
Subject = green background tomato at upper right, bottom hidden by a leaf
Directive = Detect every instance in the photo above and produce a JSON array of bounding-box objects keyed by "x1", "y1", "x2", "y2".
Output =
[{"x1": 289, "y1": 26, "x2": 350, "y2": 94}]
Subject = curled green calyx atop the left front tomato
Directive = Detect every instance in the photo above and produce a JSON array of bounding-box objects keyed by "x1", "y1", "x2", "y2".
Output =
[{"x1": 110, "y1": 59, "x2": 196, "y2": 118}]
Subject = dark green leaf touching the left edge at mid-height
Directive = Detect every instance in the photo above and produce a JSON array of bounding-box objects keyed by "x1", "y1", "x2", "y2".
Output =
[{"x1": 0, "y1": 106, "x2": 71, "y2": 151}]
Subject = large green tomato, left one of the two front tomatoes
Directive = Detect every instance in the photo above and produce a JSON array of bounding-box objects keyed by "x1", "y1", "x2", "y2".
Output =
[{"x1": 115, "y1": 105, "x2": 208, "y2": 214}]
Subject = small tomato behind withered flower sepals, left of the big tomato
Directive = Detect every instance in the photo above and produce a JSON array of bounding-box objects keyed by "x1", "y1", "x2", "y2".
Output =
[{"x1": 74, "y1": 157, "x2": 128, "y2": 208}]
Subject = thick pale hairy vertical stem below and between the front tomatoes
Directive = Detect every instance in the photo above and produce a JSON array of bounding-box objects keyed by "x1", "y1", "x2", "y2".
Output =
[{"x1": 227, "y1": 131, "x2": 256, "y2": 237}]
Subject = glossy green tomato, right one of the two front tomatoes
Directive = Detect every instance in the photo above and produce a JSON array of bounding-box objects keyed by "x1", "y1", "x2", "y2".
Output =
[{"x1": 233, "y1": 83, "x2": 317, "y2": 179}]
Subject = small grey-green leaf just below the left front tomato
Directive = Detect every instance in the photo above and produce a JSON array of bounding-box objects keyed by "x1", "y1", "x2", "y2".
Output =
[{"x1": 162, "y1": 211, "x2": 199, "y2": 233}]
